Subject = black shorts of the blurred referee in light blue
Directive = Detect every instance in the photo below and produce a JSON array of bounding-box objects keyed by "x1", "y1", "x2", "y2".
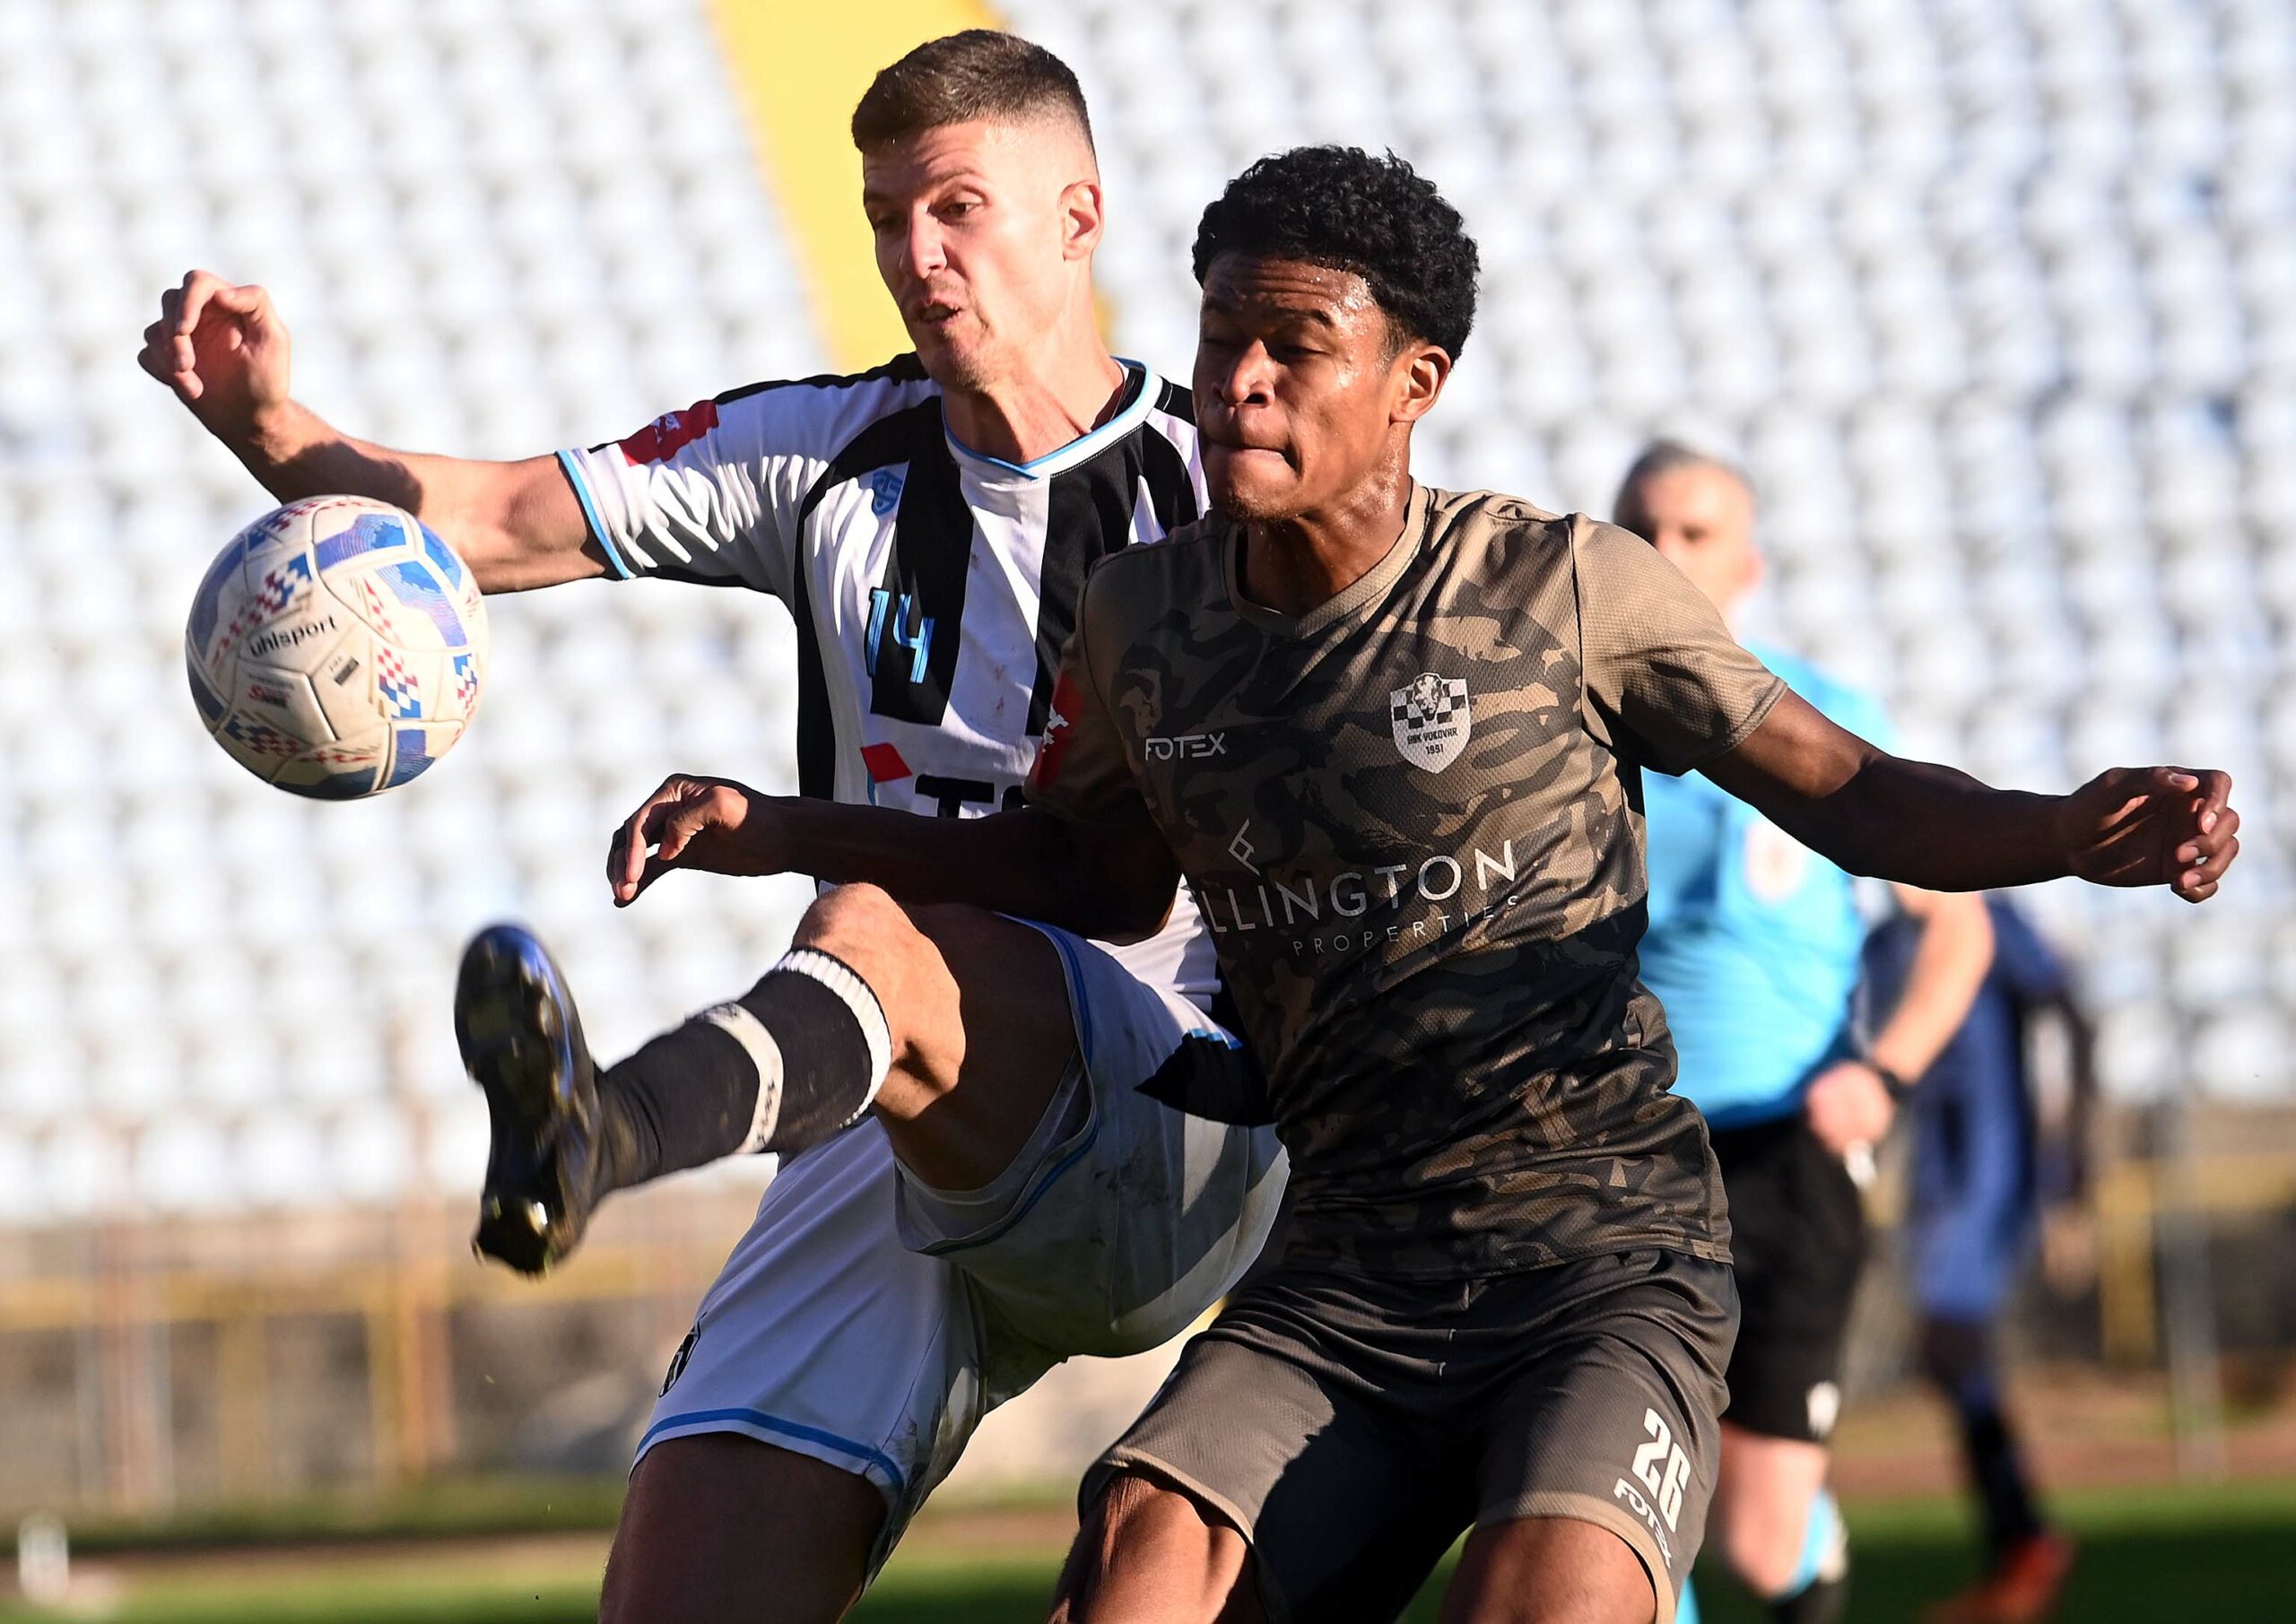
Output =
[{"x1": 1713, "y1": 1112, "x2": 1866, "y2": 1443}]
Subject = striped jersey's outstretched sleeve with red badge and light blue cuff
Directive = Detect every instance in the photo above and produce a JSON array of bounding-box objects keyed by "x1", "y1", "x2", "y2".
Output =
[{"x1": 558, "y1": 369, "x2": 927, "y2": 602}]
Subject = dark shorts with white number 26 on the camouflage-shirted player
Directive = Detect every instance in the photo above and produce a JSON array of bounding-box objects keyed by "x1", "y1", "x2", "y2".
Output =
[{"x1": 1083, "y1": 1249, "x2": 1735, "y2": 1624}]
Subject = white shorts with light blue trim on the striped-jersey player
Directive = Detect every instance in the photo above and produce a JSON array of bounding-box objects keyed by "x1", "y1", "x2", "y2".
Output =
[{"x1": 639, "y1": 925, "x2": 1286, "y2": 1571}]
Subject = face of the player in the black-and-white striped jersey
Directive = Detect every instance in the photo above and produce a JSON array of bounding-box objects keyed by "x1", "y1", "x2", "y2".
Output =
[{"x1": 861, "y1": 119, "x2": 1100, "y2": 388}]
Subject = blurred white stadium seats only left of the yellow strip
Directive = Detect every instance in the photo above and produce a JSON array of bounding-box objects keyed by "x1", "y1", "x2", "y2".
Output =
[{"x1": 0, "y1": 0, "x2": 827, "y2": 1220}]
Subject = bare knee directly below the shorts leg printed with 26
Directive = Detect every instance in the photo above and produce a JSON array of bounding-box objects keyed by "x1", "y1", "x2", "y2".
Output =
[{"x1": 1442, "y1": 1516, "x2": 1657, "y2": 1624}]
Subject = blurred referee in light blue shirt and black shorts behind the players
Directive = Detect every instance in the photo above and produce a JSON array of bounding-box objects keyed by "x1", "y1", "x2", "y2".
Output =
[{"x1": 1614, "y1": 441, "x2": 1991, "y2": 1624}]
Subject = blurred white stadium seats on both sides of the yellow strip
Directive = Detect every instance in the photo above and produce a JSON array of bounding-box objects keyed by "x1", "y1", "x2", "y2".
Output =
[{"x1": 0, "y1": 0, "x2": 2296, "y2": 1220}]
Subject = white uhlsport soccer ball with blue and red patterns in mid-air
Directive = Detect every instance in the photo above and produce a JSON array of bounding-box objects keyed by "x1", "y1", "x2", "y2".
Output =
[{"x1": 184, "y1": 496, "x2": 487, "y2": 802}]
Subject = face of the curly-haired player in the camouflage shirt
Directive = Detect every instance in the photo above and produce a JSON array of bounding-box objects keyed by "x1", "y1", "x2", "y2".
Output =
[{"x1": 1196, "y1": 253, "x2": 1451, "y2": 521}]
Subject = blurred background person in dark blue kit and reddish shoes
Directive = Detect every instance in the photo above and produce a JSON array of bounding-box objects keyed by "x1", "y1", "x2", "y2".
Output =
[{"x1": 1865, "y1": 896, "x2": 2096, "y2": 1624}]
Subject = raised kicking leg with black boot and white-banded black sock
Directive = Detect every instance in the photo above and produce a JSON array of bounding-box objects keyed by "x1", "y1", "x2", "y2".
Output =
[{"x1": 455, "y1": 887, "x2": 1077, "y2": 1272}]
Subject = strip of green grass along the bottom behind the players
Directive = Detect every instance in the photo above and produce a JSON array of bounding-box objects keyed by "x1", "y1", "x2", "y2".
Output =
[{"x1": 0, "y1": 1481, "x2": 2296, "y2": 1624}]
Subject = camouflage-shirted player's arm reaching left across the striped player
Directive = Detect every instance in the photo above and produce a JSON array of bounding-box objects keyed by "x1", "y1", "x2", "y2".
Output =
[{"x1": 606, "y1": 774, "x2": 1180, "y2": 942}]
